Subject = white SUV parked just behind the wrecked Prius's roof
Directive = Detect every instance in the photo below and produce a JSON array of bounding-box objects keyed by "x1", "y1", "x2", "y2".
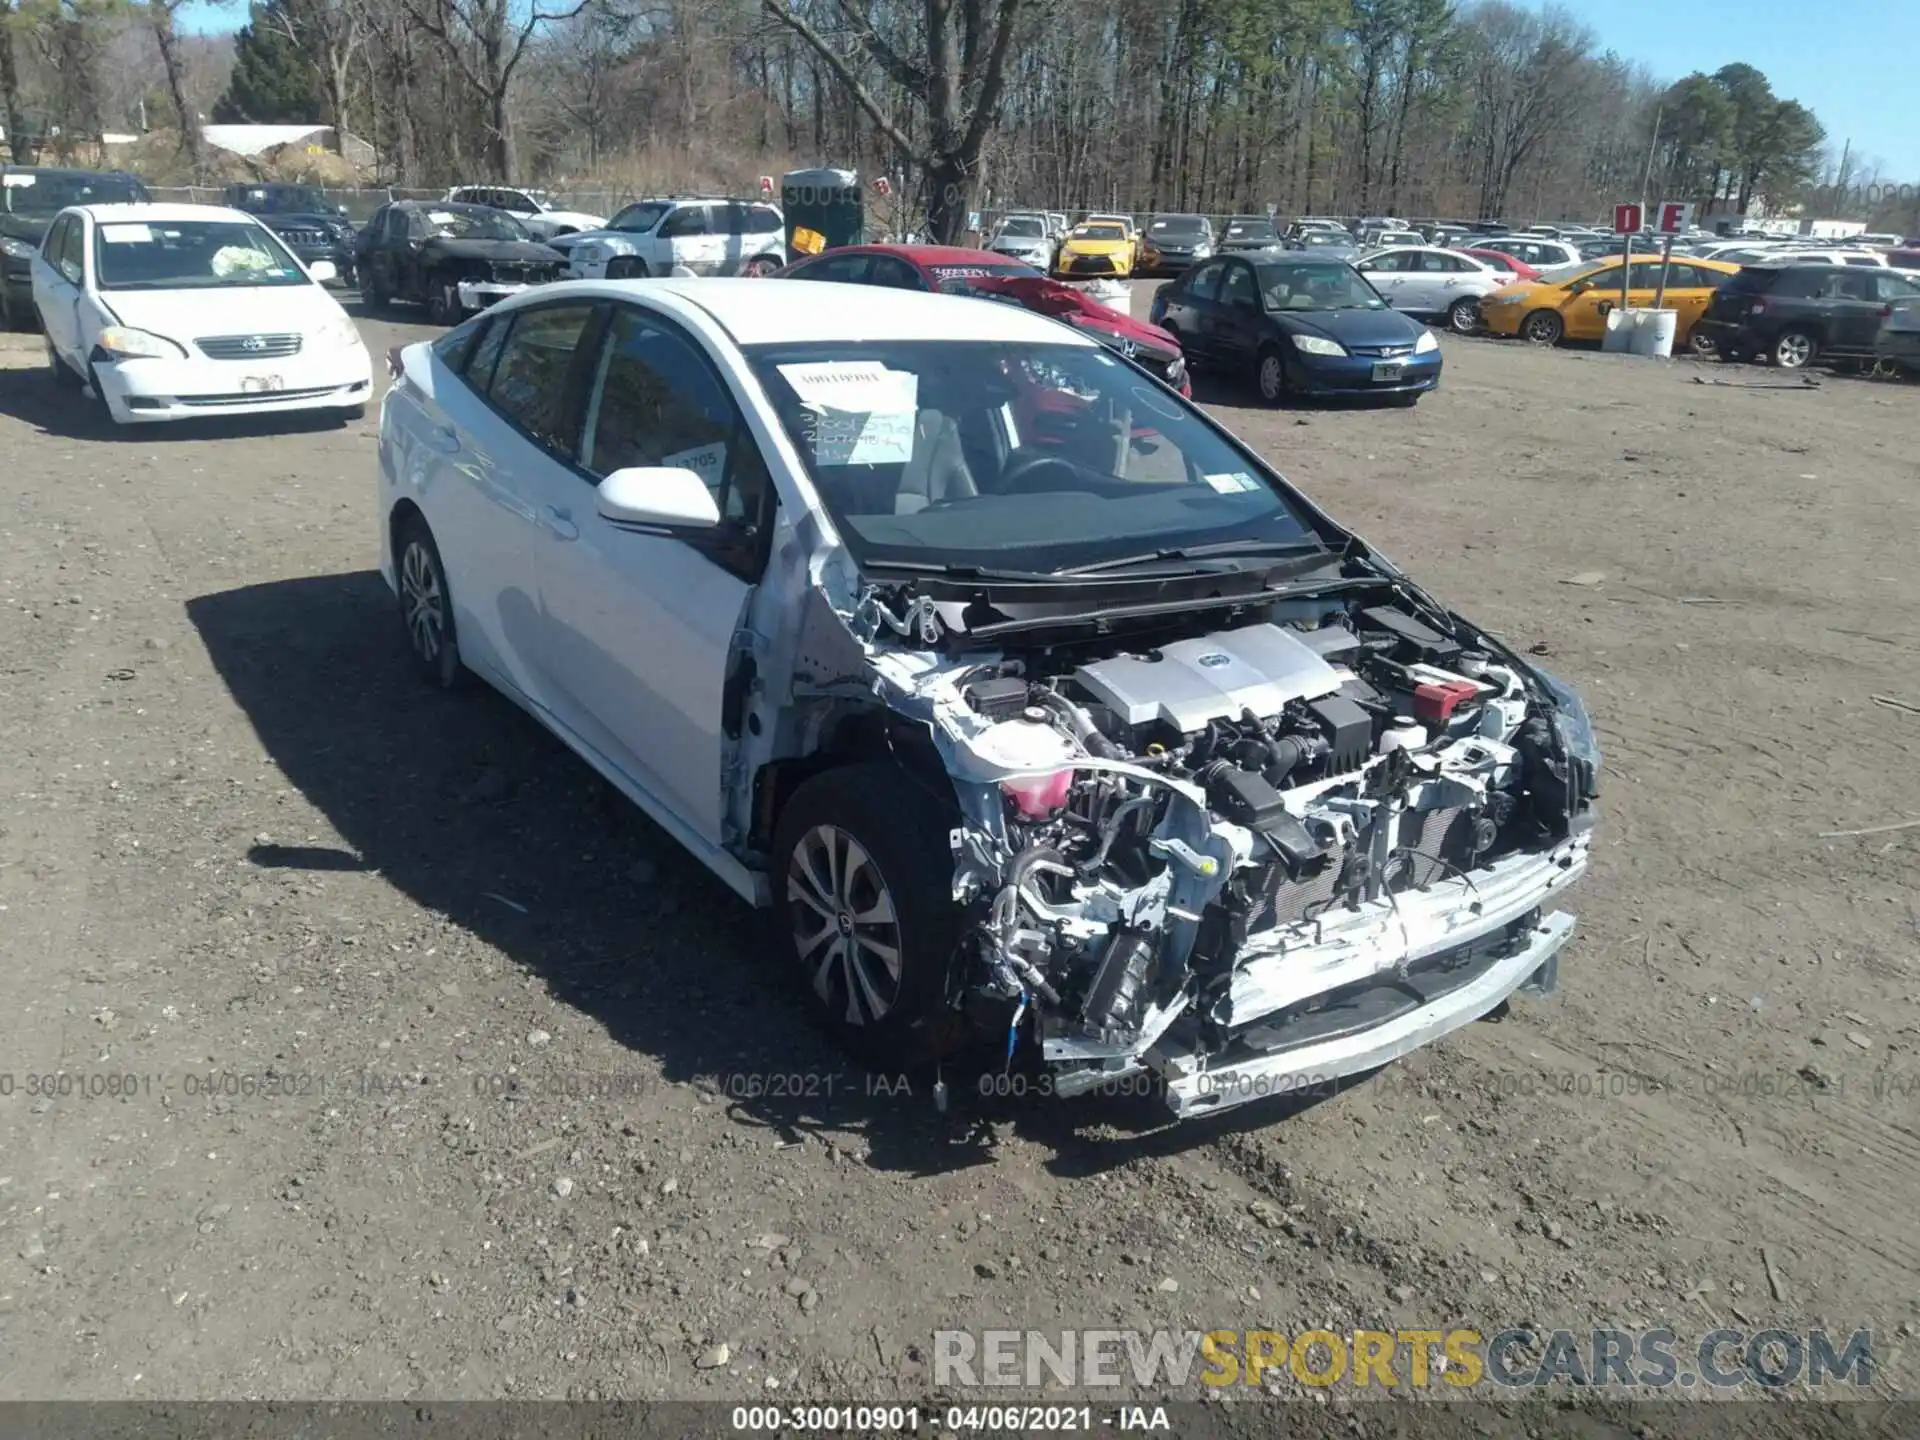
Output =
[{"x1": 555, "y1": 200, "x2": 787, "y2": 280}]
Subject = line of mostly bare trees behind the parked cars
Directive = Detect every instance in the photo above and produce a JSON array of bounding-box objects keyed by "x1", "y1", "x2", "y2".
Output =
[{"x1": 0, "y1": 0, "x2": 1872, "y2": 236}]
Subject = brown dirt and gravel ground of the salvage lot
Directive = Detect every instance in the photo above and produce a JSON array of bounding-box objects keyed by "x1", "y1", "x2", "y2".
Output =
[{"x1": 0, "y1": 284, "x2": 1920, "y2": 1436}]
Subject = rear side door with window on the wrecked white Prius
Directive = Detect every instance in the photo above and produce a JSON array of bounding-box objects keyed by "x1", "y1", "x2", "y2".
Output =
[{"x1": 420, "y1": 300, "x2": 597, "y2": 708}]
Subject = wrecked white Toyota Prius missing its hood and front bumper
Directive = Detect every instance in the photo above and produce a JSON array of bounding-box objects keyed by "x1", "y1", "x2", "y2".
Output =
[{"x1": 380, "y1": 278, "x2": 1599, "y2": 1116}]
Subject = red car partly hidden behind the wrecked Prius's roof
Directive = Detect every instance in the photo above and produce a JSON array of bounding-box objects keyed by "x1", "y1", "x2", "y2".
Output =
[{"x1": 774, "y1": 246, "x2": 1192, "y2": 396}]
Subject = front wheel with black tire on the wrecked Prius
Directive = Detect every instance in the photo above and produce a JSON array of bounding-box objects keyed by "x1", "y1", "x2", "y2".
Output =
[{"x1": 768, "y1": 764, "x2": 964, "y2": 1069}]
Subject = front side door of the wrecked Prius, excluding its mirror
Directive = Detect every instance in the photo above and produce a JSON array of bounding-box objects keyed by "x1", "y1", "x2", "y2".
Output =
[{"x1": 540, "y1": 305, "x2": 772, "y2": 845}]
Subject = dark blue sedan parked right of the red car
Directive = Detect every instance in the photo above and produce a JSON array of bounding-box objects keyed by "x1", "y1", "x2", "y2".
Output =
[{"x1": 1152, "y1": 252, "x2": 1440, "y2": 405}]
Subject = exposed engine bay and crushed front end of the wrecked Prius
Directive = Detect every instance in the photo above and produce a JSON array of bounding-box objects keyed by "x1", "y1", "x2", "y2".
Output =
[{"x1": 856, "y1": 591, "x2": 1596, "y2": 1114}]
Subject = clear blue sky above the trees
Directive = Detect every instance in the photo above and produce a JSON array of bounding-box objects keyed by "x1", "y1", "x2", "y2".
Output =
[{"x1": 180, "y1": 0, "x2": 1920, "y2": 180}]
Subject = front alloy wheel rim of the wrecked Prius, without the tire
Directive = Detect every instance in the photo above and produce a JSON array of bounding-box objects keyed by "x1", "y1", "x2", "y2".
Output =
[{"x1": 787, "y1": 824, "x2": 900, "y2": 1025}]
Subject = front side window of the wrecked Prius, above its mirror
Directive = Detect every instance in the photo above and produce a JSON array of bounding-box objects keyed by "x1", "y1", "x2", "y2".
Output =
[{"x1": 580, "y1": 309, "x2": 770, "y2": 552}]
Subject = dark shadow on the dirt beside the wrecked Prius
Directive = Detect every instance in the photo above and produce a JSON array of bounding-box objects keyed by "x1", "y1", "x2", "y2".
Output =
[{"x1": 186, "y1": 570, "x2": 1351, "y2": 1175}]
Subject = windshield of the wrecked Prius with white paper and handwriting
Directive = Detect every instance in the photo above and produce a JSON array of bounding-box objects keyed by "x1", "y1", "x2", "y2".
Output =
[{"x1": 747, "y1": 340, "x2": 1319, "y2": 570}]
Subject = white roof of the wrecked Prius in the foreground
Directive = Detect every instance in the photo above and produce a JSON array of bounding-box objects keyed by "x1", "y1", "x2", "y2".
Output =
[{"x1": 591, "y1": 278, "x2": 1098, "y2": 346}]
